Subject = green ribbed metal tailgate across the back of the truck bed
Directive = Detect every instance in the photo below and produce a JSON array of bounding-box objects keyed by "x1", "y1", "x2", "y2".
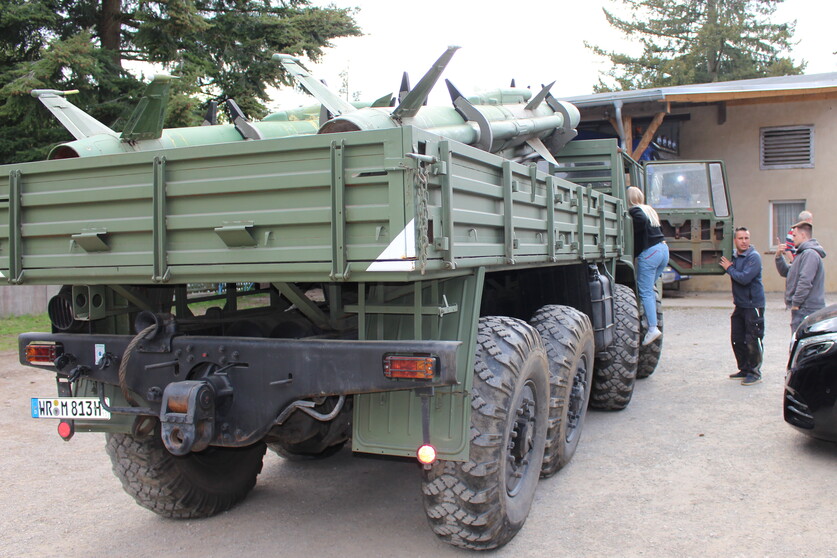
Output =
[{"x1": 0, "y1": 129, "x2": 412, "y2": 284}]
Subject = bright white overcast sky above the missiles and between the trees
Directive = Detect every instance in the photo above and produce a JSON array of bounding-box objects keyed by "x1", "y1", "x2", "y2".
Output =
[{"x1": 271, "y1": 0, "x2": 837, "y2": 109}]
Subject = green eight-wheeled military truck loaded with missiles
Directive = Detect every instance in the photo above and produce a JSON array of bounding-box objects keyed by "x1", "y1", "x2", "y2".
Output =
[{"x1": 0, "y1": 49, "x2": 731, "y2": 550}]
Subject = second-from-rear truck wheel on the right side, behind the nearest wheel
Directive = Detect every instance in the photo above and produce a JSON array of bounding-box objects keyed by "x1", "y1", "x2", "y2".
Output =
[{"x1": 529, "y1": 306, "x2": 594, "y2": 477}]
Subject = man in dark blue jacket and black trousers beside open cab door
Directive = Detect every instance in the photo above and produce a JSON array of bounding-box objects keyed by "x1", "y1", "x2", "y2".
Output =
[{"x1": 721, "y1": 227, "x2": 765, "y2": 386}]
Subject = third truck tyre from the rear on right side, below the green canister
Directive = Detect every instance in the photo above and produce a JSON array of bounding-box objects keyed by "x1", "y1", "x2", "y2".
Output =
[{"x1": 590, "y1": 284, "x2": 640, "y2": 411}]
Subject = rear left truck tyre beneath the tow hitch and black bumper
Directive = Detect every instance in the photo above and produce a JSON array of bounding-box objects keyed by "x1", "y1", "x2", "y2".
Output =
[{"x1": 106, "y1": 429, "x2": 265, "y2": 519}]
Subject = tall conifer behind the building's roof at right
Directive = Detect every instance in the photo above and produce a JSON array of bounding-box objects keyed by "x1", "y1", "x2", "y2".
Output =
[{"x1": 585, "y1": 0, "x2": 805, "y2": 92}]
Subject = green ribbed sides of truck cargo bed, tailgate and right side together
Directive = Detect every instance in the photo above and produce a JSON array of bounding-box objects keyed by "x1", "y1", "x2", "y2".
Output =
[{"x1": 0, "y1": 127, "x2": 624, "y2": 284}]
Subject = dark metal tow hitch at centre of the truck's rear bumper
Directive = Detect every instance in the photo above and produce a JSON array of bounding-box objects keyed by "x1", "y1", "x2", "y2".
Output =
[{"x1": 160, "y1": 381, "x2": 215, "y2": 455}]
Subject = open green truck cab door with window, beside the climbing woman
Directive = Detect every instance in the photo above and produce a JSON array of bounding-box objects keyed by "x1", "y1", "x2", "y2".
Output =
[{"x1": 643, "y1": 161, "x2": 733, "y2": 275}]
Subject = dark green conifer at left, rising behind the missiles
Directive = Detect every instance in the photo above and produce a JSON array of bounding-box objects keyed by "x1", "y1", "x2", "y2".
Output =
[{"x1": 0, "y1": 0, "x2": 360, "y2": 163}]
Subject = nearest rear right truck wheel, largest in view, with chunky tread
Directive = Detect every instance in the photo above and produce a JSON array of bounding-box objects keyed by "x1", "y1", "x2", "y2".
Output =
[{"x1": 422, "y1": 317, "x2": 549, "y2": 550}]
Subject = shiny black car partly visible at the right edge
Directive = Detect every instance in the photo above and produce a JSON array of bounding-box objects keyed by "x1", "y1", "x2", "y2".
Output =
[{"x1": 785, "y1": 304, "x2": 837, "y2": 442}]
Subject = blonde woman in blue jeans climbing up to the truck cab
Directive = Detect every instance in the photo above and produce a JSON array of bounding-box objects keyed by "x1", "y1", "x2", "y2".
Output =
[{"x1": 627, "y1": 186, "x2": 668, "y2": 345}]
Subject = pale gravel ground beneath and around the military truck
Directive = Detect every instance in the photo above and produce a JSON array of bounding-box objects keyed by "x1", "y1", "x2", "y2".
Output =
[{"x1": 0, "y1": 293, "x2": 837, "y2": 558}]
